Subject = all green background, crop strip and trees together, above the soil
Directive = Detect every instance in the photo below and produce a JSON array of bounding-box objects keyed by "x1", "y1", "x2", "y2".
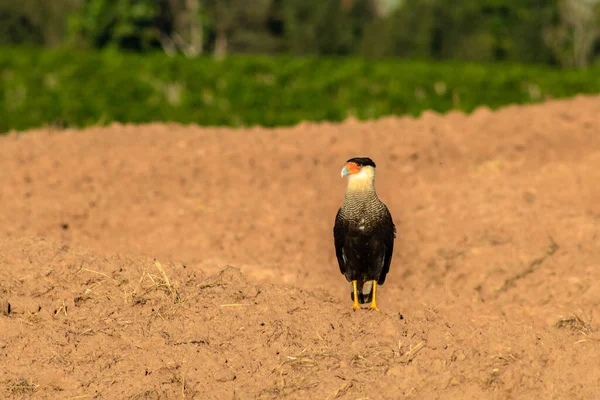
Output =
[{"x1": 0, "y1": 0, "x2": 600, "y2": 132}]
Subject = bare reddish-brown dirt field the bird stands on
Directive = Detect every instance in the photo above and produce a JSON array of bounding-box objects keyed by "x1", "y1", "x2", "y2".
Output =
[{"x1": 0, "y1": 97, "x2": 600, "y2": 399}]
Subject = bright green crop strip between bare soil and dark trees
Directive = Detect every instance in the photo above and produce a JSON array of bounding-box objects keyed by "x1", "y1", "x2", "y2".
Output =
[{"x1": 0, "y1": 48, "x2": 600, "y2": 132}]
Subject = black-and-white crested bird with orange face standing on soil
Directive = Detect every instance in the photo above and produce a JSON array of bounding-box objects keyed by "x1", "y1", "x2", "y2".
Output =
[{"x1": 333, "y1": 157, "x2": 396, "y2": 311}]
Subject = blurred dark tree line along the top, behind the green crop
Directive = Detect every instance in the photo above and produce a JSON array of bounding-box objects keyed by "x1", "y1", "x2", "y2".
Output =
[{"x1": 0, "y1": 0, "x2": 600, "y2": 68}]
